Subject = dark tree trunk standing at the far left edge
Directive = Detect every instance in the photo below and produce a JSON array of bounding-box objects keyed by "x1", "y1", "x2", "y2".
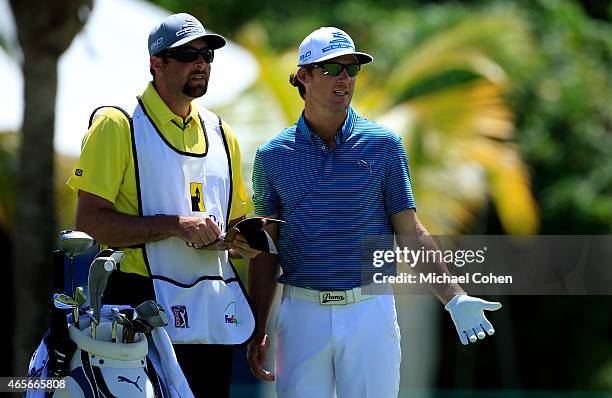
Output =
[{"x1": 10, "y1": 0, "x2": 92, "y2": 374}]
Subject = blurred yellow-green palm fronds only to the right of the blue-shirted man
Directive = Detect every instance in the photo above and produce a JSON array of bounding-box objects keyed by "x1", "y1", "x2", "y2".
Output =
[{"x1": 364, "y1": 14, "x2": 539, "y2": 234}]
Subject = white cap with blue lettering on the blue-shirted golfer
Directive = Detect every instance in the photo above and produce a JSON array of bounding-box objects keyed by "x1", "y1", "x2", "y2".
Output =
[{"x1": 298, "y1": 26, "x2": 374, "y2": 66}]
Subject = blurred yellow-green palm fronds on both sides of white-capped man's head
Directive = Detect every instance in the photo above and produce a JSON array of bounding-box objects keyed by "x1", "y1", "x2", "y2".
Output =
[{"x1": 219, "y1": 14, "x2": 539, "y2": 234}]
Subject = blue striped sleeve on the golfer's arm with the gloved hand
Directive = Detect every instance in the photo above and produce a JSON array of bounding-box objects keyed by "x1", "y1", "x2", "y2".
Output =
[{"x1": 383, "y1": 135, "x2": 416, "y2": 217}]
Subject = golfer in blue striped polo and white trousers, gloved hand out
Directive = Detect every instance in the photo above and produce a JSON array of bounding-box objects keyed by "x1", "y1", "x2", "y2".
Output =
[{"x1": 248, "y1": 27, "x2": 501, "y2": 398}]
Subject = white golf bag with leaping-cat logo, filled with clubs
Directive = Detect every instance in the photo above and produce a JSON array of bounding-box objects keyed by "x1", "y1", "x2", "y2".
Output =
[{"x1": 25, "y1": 232, "x2": 193, "y2": 398}]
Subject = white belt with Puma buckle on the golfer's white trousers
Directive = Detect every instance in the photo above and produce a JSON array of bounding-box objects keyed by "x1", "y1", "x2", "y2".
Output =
[{"x1": 283, "y1": 285, "x2": 372, "y2": 305}]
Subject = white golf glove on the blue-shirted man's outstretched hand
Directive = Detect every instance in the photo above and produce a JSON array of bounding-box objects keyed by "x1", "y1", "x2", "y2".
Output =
[{"x1": 444, "y1": 294, "x2": 501, "y2": 345}]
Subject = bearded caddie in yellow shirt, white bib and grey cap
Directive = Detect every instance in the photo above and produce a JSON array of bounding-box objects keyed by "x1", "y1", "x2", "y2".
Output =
[{"x1": 67, "y1": 13, "x2": 259, "y2": 398}]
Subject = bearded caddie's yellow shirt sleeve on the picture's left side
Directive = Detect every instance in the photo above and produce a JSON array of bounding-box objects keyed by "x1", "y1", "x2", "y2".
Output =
[{"x1": 66, "y1": 108, "x2": 132, "y2": 204}]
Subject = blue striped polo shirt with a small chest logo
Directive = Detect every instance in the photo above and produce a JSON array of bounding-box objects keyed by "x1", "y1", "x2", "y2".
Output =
[{"x1": 253, "y1": 108, "x2": 415, "y2": 290}]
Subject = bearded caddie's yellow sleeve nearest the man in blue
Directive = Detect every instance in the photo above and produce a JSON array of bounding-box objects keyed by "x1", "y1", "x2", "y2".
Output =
[{"x1": 221, "y1": 121, "x2": 253, "y2": 220}]
